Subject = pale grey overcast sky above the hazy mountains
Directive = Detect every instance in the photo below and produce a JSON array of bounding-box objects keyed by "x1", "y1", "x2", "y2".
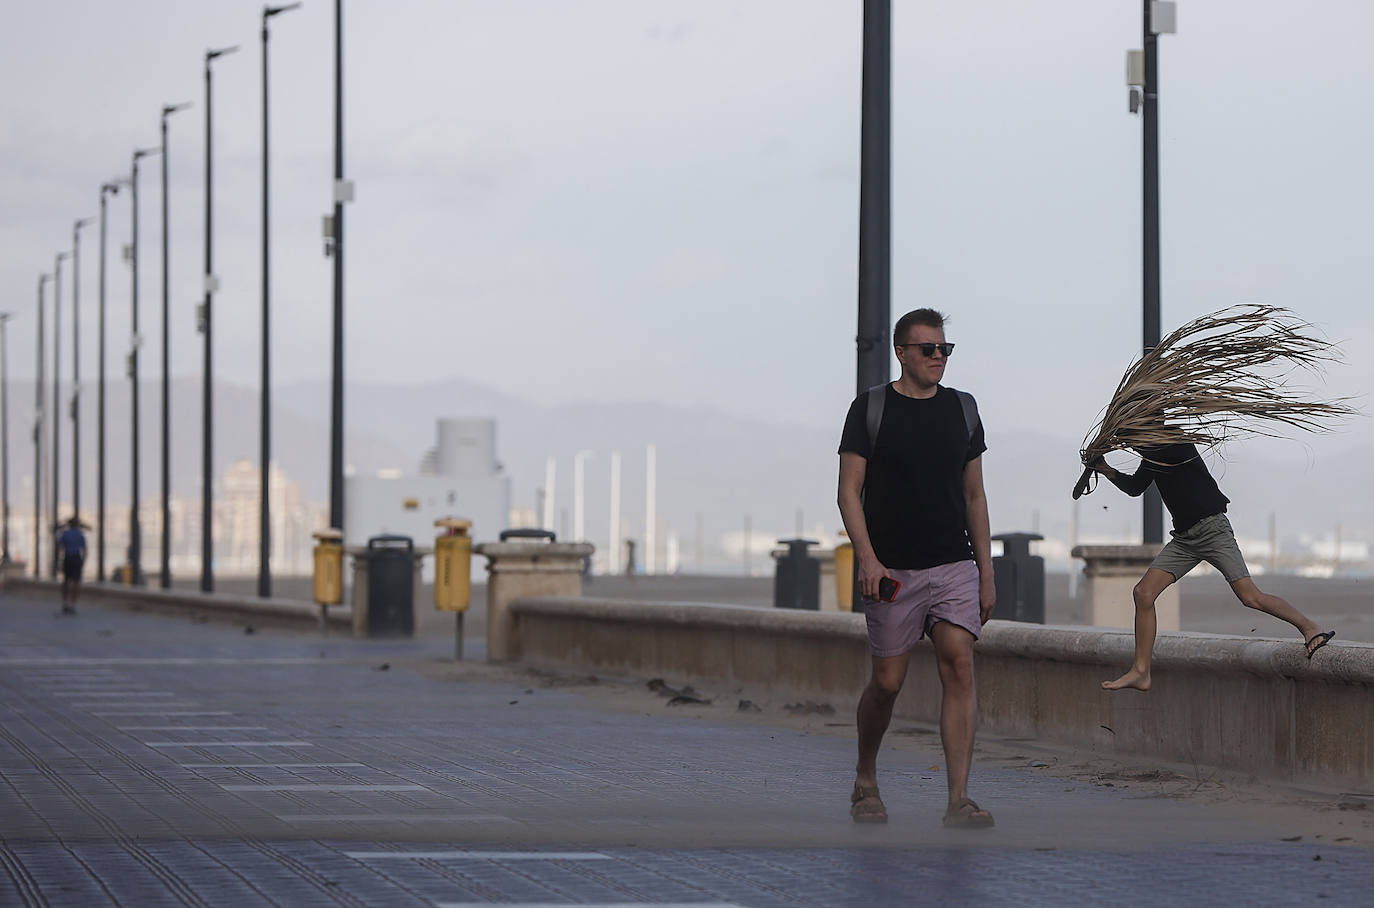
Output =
[{"x1": 0, "y1": 0, "x2": 1374, "y2": 461}]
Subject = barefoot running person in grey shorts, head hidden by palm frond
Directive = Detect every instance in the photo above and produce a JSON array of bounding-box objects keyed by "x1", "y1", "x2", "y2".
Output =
[{"x1": 1090, "y1": 444, "x2": 1336, "y2": 691}]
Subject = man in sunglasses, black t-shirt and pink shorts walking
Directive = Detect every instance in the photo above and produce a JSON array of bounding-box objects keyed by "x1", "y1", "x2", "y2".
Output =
[{"x1": 840, "y1": 309, "x2": 996, "y2": 827}]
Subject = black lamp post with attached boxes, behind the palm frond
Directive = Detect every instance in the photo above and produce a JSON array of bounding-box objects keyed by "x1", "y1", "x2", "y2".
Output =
[{"x1": 1127, "y1": 0, "x2": 1176, "y2": 543}]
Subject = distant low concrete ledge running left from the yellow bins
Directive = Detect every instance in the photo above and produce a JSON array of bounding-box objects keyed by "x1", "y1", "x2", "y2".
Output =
[{"x1": 4, "y1": 574, "x2": 353, "y2": 629}]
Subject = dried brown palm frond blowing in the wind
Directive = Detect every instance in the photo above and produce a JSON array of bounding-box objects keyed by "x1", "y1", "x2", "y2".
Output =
[{"x1": 1073, "y1": 305, "x2": 1359, "y2": 497}]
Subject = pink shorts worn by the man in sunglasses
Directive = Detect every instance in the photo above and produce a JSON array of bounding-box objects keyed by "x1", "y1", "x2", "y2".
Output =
[{"x1": 863, "y1": 560, "x2": 982, "y2": 657}]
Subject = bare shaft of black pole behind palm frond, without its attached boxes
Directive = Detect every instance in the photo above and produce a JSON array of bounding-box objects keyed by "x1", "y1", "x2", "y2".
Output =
[{"x1": 1142, "y1": 0, "x2": 1164, "y2": 544}]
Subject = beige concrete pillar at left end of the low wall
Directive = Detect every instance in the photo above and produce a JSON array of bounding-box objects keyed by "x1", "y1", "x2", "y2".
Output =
[{"x1": 477, "y1": 541, "x2": 596, "y2": 662}]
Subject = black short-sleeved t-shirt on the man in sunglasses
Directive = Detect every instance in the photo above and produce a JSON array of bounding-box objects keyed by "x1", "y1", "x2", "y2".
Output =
[{"x1": 840, "y1": 385, "x2": 988, "y2": 570}]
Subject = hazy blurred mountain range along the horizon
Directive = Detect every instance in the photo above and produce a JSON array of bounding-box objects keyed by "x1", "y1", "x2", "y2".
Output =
[{"x1": 8, "y1": 378, "x2": 1374, "y2": 570}]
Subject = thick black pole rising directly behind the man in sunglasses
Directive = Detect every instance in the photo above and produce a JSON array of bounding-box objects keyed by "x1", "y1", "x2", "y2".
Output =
[{"x1": 856, "y1": 0, "x2": 892, "y2": 391}]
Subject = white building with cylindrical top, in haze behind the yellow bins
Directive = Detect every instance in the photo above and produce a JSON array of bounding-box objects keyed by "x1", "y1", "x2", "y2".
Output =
[{"x1": 344, "y1": 419, "x2": 511, "y2": 580}]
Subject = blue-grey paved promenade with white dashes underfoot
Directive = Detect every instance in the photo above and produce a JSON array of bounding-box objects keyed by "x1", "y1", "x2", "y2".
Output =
[{"x1": 0, "y1": 593, "x2": 1374, "y2": 908}]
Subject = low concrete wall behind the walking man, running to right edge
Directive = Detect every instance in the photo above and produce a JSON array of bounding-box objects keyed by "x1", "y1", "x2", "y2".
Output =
[{"x1": 511, "y1": 599, "x2": 1374, "y2": 786}]
